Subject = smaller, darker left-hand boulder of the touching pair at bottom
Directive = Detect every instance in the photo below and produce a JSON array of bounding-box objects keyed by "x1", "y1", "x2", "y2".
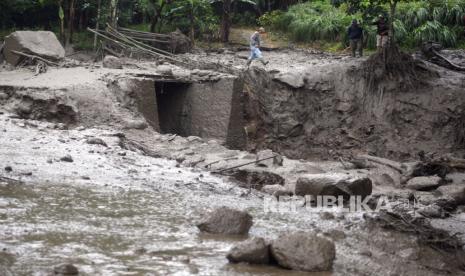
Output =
[{"x1": 226, "y1": 238, "x2": 270, "y2": 264}]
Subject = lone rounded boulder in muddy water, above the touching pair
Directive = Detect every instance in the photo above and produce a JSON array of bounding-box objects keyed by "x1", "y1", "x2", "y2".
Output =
[{"x1": 197, "y1": 207, "x2": 253, "y2": 235}]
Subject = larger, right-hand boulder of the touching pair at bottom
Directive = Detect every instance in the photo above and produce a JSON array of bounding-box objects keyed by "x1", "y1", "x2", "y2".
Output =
[{"x1": 271, "y1": 232, "x2": 336, "y2": 271}]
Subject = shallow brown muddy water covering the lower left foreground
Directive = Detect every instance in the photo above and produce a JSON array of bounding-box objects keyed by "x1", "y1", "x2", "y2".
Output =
[{"x1": 0, "y1": 174, "x2": 330, "y2": 275}]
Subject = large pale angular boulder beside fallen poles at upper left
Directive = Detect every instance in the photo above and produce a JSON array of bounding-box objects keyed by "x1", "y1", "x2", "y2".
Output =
[{"x1": 3, "y1": 31, "x2": 65, "y2": 66}]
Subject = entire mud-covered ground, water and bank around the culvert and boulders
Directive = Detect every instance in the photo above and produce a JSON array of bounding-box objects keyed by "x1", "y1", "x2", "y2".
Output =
[{"x1": 0, "y1": 50, "x2": 465, "y2": 275}]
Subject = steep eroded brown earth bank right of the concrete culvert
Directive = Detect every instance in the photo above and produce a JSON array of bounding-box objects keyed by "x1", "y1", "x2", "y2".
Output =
[{"x1": 183, "y1": 50, "x2": 465, "y2": 161}]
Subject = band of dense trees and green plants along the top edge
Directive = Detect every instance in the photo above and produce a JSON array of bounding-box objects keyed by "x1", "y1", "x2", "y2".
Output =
[{"x1": 0, "y1": 0, "x2": 465, "y2": 48}]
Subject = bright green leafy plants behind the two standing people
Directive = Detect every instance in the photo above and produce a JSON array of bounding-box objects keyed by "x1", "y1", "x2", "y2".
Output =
[{"x1": 259, "y1": 0, "x2": 465, "y2": 48}]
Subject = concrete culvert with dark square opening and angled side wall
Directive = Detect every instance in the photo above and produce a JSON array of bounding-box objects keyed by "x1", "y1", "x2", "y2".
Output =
[{"x1": 111, "y1": 77, "x2": 246, "y2": 148}]
